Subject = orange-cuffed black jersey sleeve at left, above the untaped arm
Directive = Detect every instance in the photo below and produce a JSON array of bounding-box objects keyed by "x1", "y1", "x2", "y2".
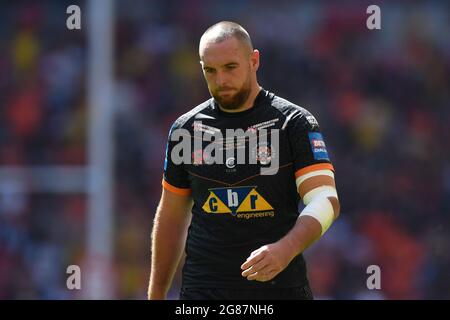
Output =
[{"x1": 162, "y1": 123, "x2": 191, "y2": 196}]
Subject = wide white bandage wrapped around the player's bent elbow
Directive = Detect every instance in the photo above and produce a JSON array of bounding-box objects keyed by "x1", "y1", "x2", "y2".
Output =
[{"x1": 300, "y1": 186, "x2": 337, "y2": 235}]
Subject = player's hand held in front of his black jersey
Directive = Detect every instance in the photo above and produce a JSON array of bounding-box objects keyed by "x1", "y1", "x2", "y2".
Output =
[{"x1": 241, "y1": 241, "x2": 295, "y2": 282}]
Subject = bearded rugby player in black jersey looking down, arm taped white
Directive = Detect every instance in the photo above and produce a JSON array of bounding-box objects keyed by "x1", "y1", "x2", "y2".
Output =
[{"x1": 148, "y1": 21, "x2": 340, "y2": 299}]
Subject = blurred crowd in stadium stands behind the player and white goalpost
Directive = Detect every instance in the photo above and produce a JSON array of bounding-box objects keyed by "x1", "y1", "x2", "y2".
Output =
[{"x1": 0, "y1": 0, "x2": 450, "y2": 299}]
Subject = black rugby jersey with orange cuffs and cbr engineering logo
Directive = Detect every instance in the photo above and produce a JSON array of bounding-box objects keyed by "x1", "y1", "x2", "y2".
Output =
[{"x1": 163, "y1": 90, "x2": 334, "y2": 288}]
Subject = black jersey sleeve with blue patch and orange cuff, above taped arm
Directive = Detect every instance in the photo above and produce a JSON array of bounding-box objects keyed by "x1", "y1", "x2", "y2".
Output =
[{"x1": 288, "y1": 109, "x2": 334, "y2": 177}]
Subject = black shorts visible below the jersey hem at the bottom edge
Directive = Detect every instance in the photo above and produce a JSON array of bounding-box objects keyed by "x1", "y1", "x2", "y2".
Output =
[{"x1": 180, "y1": 285, "x2": 313, "y2": 300}]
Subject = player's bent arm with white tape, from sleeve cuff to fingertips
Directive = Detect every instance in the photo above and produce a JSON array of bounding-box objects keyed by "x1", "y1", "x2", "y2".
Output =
[{"x1": 241, "y1": 169, "x2": 340, "y2": 281}]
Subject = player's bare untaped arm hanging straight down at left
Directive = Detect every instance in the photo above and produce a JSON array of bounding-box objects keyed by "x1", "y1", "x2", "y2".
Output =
[{"x1": 148, "y1": 188, "x2": 193, "y2": 300}]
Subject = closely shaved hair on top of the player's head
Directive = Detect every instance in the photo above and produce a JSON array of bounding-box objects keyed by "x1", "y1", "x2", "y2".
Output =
[{"x1": 198, "y1": 21, "x2": 253, "y2": 59}]
